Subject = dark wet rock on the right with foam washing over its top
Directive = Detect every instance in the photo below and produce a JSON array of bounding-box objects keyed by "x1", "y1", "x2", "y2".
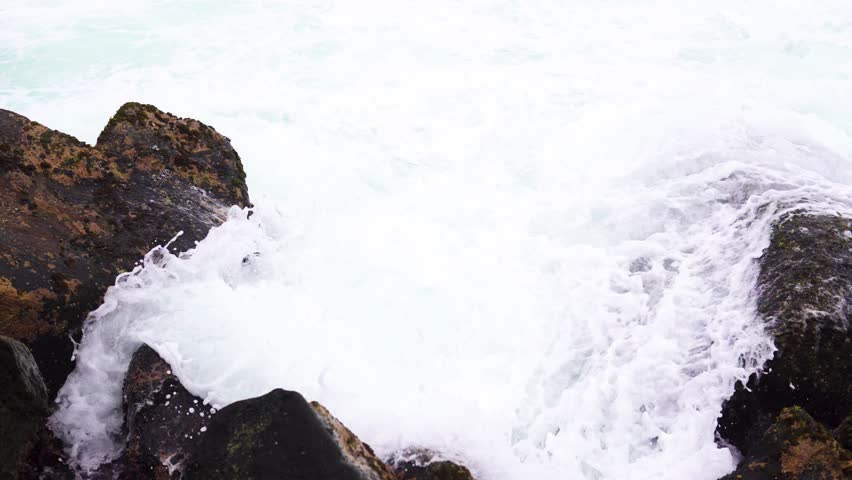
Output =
[{"x1": 718, "y1": 212, "x2": 852, "y2": 456}]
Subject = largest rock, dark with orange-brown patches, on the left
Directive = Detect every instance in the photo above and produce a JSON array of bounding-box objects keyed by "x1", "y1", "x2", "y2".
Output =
[{"x1": 0, "y1": 103, "x2": 249, "y2": 396}]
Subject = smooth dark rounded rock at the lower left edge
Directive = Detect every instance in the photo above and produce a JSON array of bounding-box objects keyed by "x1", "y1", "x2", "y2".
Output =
[{"x1": 0, "y1": 336, "x2": 48, "y2": 480}]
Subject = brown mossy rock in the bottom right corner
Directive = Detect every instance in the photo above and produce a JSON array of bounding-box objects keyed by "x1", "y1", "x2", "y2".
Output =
[{"x1": 722, "y1": 407, "x2": 852, "y2": 480}]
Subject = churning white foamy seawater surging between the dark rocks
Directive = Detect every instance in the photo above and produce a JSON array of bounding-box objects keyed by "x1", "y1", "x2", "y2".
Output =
[{"x1": 0, "y1": 0, "x2": 852, "y2": 480}]
